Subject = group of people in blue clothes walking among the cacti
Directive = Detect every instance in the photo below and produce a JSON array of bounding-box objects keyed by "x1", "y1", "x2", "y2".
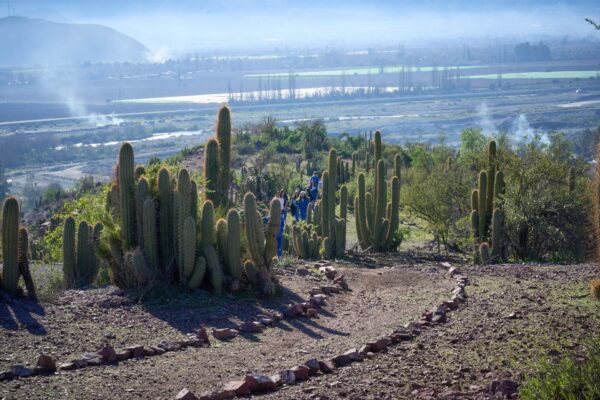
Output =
[{"x1": 273, "y1": 171, "x2": 319, "y2": 256}]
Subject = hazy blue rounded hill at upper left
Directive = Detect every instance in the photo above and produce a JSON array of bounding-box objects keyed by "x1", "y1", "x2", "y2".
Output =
[{"x1": 0, "y1": 17, "x2": 148, "y2": 65}]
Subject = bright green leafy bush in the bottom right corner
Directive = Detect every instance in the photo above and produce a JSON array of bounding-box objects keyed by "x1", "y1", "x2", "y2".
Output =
[{"x1": 519, "y1": 342, "x2": 600, "y2": 400}]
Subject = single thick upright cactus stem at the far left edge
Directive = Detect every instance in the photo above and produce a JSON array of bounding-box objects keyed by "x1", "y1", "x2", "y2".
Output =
[{"x1": 2, "y1": 197, "x2": 19, "y2": 295}]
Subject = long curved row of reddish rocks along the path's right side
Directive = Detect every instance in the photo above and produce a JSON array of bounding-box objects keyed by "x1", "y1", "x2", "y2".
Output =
[{"x1": 175, "y1": 262, "x2": 469, "y2": 400}]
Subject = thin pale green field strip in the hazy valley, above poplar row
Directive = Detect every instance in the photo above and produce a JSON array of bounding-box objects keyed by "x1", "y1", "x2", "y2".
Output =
[{"x1": 244, "y1": 65, "x2": 485, "y2": 78}]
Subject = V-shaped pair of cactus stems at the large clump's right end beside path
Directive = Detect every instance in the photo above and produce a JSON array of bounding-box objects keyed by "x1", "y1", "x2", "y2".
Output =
[{"x1": 244, "y1": 193, "x2": 281, "y2": 295}]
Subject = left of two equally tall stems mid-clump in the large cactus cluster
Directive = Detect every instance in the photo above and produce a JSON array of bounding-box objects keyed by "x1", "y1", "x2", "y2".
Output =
[{"x1": 156, "y1": 168, "x2": 175, "y2": 272}]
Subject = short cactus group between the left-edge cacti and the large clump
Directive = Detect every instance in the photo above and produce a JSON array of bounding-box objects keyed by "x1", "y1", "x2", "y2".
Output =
[{"x1": 63, "y1": 217, "x2": 102, "y2": 288}]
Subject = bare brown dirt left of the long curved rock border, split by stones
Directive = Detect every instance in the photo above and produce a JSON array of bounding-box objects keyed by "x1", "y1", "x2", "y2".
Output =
[{"x1": 0, "y1": 260, "x2": 453, "y2": 399}]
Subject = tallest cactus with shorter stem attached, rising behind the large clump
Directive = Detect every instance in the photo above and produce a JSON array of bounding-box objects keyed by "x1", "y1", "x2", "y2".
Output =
[{"x1": 204, "y1": 106, "x2": 231, "y2": 207}]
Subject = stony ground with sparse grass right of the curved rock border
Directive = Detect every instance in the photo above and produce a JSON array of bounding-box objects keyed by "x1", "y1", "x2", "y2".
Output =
[{"x1": 265, "y1": 265, "x2": 600, "y2": 400}]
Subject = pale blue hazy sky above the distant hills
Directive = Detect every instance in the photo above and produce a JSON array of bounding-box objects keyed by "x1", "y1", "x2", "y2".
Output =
[{"x1": 8, "y1": 0, "x2": 600, "y2": 52}]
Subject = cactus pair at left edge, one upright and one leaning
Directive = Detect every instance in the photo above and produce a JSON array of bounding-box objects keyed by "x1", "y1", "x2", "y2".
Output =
[{"x1": 0, "y1": 197, "x2": 37, "y2": 300}]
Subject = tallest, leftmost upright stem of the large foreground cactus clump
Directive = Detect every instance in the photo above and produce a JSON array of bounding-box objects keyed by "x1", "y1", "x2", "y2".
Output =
[{"x1": 118, "y1": 142, "x2": 137, "y2": 250}]
